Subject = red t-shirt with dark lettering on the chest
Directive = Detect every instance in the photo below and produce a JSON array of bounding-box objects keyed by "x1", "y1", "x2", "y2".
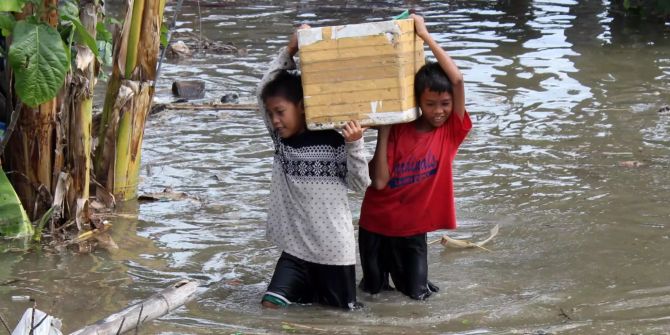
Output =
[{"x1": 359, "y1": 112, "x2": 472, "y2": 236}]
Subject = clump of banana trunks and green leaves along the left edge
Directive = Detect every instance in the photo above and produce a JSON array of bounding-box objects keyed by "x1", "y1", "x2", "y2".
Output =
[{"x1": 0, "y1": 0, "x2": 165, "y2": 249}]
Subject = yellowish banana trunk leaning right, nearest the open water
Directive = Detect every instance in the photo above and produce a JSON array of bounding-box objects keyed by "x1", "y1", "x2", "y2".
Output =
[{"x1": 95, "y1": 0, "x2": 165, "y2": 201}]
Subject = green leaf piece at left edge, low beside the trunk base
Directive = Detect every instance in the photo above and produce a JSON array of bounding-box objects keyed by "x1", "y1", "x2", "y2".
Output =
[{"x1": 0, "y1": 169, "x2": 33, "y2": 238}]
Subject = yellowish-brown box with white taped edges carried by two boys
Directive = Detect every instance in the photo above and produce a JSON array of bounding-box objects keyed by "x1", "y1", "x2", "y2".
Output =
[{"x1": 298, "y1": 19, "x2": 425, "y2": 130}]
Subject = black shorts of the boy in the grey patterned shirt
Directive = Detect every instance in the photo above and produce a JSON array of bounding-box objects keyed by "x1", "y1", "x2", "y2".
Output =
[{"x1": 265, "y1": 252, "x2": 360, "y2": 309}]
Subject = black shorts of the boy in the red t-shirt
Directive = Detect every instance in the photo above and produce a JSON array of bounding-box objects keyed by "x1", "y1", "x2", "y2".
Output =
[{"x1": 358, "y1": 228, "x2": 437, "y2": 300}]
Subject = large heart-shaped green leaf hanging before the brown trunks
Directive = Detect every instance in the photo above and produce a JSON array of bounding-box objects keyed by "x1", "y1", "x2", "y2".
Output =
[{"x1": 9, "y1": 21, "x2": 69, "y2": 106}]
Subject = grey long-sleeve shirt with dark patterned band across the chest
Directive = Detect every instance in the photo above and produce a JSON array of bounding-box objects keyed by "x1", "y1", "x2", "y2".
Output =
[{"x1": 257, "y1": 48, "x2": 370, "y2": 265}]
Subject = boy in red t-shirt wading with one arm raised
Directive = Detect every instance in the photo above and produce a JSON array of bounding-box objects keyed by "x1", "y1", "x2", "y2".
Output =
[{"x1": 358, "y1": 14, "x2": 472, "y2": 300}]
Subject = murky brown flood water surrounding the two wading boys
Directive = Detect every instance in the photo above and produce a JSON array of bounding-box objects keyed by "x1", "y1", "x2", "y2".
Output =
[{"x1": 0, "y1": 0, "x2": 670, "y2": 335}]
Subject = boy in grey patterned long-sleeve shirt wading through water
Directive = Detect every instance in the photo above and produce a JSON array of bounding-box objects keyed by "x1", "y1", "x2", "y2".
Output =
[{"x1": 258, "y1": 26, "x2": 370, "y2": 309}]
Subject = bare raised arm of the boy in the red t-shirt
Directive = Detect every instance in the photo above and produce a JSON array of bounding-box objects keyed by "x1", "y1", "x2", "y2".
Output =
[{"x1": 411, "y1": 14, "x2": 465, "y2": 119}]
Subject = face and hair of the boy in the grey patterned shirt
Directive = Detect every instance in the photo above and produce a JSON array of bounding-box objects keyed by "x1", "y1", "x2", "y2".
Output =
[{"x1": 265, "y1": 96, "x2": 305, "y2": 138}]
